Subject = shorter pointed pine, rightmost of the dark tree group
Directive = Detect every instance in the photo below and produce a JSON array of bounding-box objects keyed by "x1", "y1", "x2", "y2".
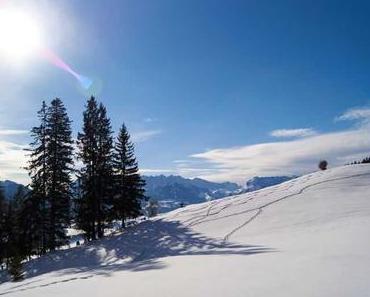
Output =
[{"x1": 113, "y1": 124, "x2": 145, "y2": 228}]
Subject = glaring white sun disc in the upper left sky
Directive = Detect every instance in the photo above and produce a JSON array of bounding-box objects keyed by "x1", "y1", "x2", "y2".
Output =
[{"x1": 0, "y1": 9, "x2": 42, "y2": 60}]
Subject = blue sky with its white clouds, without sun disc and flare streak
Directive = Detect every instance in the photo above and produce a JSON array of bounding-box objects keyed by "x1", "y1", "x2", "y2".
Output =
[{"x1": 0, "y1": 0, "x2": 370, "y2": 182}]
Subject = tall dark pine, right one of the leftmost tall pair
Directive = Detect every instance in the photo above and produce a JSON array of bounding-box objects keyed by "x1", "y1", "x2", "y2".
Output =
[{"x1": 46, "y1": 98, "x2": 73, "y2": 250}]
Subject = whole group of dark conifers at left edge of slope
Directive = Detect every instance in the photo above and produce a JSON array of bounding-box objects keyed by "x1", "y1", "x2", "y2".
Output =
[{"x1": 0, "y1": 97, "x2": 144, "y2": 281}]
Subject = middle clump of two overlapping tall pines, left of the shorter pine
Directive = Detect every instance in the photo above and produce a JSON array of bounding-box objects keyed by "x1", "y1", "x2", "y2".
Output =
[{"x1": 76, "y1": 97, "x2": 113, "y2": 240}]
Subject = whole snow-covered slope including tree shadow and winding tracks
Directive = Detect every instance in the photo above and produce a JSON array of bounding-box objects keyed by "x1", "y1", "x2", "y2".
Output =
[{"x1": 0, "y1": 165, "x2": 370, "y2": 297}]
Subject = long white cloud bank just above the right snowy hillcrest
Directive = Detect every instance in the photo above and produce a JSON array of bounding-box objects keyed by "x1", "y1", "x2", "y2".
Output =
[{"x1": 191, "y1": 128, "x2": 370, "y2": 183}]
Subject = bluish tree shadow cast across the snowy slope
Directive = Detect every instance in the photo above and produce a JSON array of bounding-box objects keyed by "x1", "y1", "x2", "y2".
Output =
[{"x1": 0, "y1": 220, "x2": 272, "y2": 295}]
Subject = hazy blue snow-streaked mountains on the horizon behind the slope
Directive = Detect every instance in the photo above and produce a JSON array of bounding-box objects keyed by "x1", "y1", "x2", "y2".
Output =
[{"x1": 0, "y1": 175, "x2": 295, "y2": 212}]
